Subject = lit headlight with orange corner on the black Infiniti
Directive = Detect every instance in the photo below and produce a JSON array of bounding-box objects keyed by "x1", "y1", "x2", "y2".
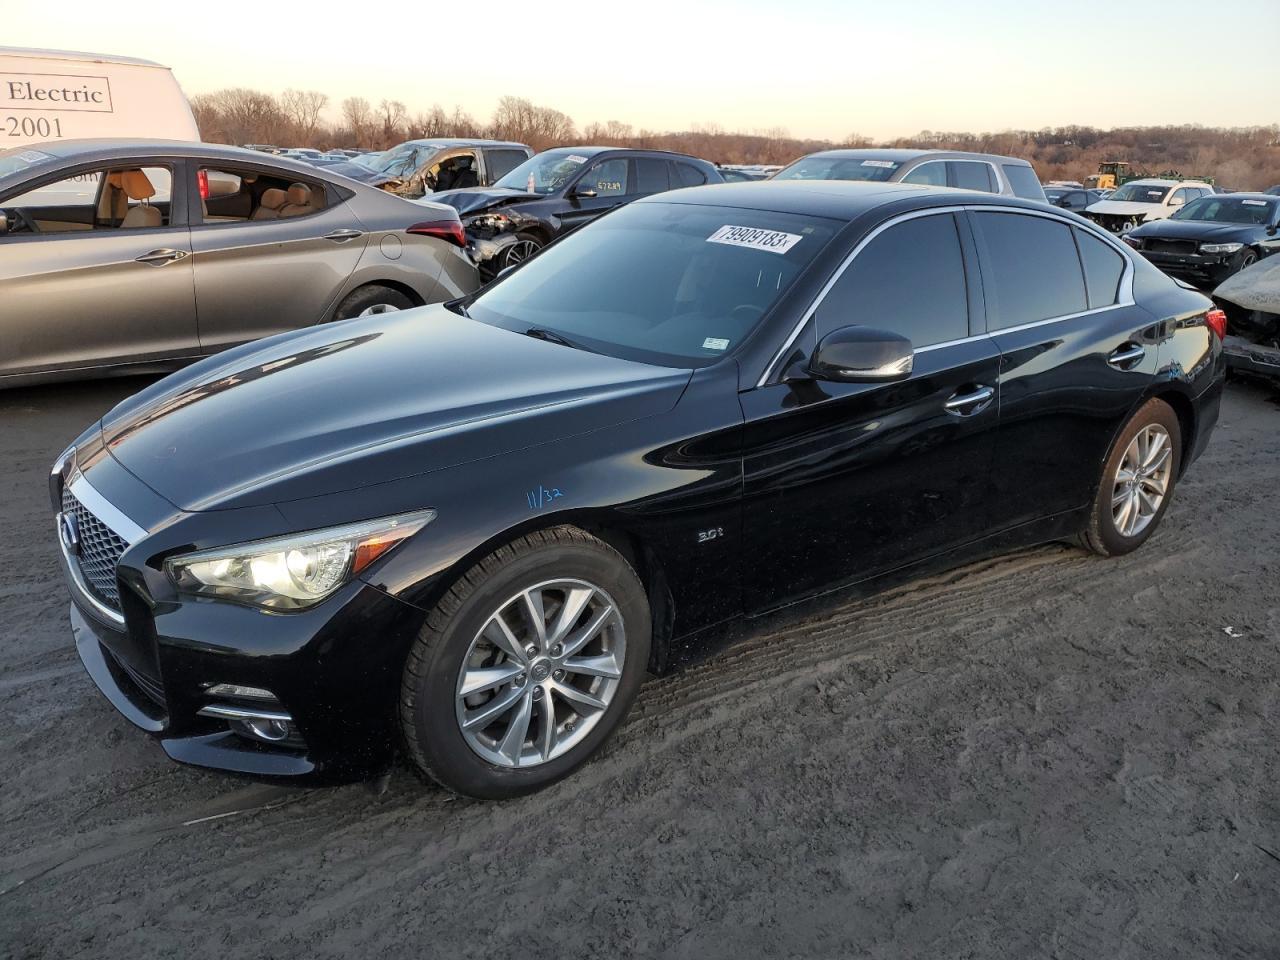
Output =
[{"x1": 164, "y1": 509, "x2": 435, "y2": 611}]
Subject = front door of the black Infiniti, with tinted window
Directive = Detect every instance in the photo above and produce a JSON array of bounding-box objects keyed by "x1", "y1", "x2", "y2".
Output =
[{"x1": 741, "y1": 212, "x2": 1000, "y2": 612}]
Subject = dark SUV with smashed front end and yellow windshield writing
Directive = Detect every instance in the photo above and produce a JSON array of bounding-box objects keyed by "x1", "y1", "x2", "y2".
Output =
[{"x1": 429, "y1": 147, "x2": 723, "y2": 278}]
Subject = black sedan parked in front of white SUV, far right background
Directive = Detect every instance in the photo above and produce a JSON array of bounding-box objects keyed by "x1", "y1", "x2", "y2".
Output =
[{"x1": 1124, "y1": 193, "x2": 1280, "y2": 285}]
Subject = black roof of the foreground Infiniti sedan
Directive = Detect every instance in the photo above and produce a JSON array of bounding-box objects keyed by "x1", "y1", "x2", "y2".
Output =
[{"x1": 634, "y1": 180, "x2": 1044, "y2": 220}]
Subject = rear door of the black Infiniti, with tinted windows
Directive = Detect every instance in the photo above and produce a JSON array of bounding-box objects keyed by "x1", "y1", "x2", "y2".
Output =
[{"x1": 969, "y1": 210, "x2": 1161, "y2": 527}]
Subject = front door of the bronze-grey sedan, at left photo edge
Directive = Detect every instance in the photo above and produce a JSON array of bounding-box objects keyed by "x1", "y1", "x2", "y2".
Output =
[{"x1": 0, "y1": 160, "x2": 198, "y2": 376}]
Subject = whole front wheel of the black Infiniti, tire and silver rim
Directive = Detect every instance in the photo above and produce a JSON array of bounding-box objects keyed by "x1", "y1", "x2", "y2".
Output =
[{"x1": 399, "y1": 526, "x2": 652, "y2": 800}]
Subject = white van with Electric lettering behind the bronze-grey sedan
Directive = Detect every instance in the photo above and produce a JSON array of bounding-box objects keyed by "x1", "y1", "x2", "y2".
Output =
[{"x1": 0, "y1": 46, "x2": 200, "y2": 147}]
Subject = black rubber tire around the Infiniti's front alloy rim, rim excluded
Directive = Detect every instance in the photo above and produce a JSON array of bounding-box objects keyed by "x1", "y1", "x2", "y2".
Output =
[{"x1": 406, "y1": 544, "x2": 652, "y2": 800}]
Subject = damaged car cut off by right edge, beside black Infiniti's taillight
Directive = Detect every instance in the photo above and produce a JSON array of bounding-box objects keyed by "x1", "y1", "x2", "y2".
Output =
[{"x1": 1213, "y1": 257, "x2": 1280, "y2": 380}]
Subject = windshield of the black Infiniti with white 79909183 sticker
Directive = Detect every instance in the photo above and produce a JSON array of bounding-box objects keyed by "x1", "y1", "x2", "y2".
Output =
[{"x1": 466, "y1": 202, "x2": 841, "y2": 366}]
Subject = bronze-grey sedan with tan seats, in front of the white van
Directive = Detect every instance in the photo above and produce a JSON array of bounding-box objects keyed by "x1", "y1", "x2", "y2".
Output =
[{"x1": 0, "y1": 140, "x2": 479, "y2": 387}]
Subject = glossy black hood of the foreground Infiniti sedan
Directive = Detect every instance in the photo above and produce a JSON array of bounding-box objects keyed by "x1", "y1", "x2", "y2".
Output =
[{"x1": 102, "y1": 312, "x2": 691, "y2": 511}]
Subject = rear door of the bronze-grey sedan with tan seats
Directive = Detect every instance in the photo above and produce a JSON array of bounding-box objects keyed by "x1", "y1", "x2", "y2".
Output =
[{"x1": 189, "y1": 161, "x2": 369, "y2": 353}]
